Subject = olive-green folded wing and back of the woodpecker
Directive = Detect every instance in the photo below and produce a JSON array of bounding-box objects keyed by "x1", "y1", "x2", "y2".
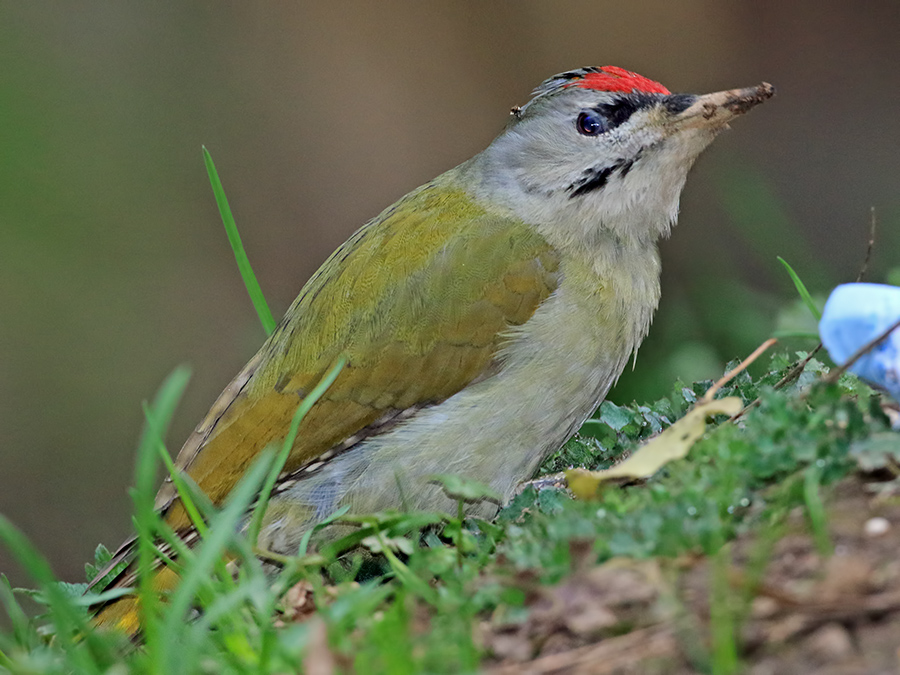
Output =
[{"x1": 157, "y1": 183, "x2": 559, "y2": 529}]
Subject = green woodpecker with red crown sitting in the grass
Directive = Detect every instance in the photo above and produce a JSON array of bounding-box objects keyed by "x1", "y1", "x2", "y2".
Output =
[{"x1": 91, "y1": 66, "x2": 774, "y2": 633}]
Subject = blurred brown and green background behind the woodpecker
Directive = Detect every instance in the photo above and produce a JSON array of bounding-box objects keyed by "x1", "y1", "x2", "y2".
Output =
[{"x1": 0, "y1": 0, "x2": 900, "y2": 583}]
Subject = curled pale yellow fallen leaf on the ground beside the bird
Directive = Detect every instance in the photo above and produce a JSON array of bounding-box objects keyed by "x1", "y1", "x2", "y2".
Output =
[{"x1": 565, "y1": 396, "x2": 743, "y2": 499}]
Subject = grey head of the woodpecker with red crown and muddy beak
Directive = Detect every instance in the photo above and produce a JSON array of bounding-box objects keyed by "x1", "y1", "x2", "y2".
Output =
[{"x1": 481, "y1": 66, "x2": 774, "y2": 251}]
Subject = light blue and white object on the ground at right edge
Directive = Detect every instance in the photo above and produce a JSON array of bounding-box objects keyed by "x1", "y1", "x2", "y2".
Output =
[{"x1": 819, "y1": 284, "x2": 900, "y2": 400}]
